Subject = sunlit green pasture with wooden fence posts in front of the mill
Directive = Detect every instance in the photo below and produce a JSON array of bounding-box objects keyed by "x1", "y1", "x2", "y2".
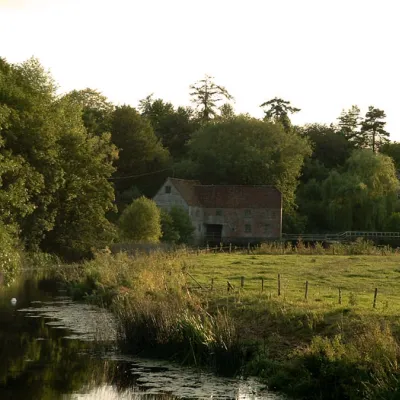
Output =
[{"x1": 187, "y1": 253, "x2": 400, "y2": 316}]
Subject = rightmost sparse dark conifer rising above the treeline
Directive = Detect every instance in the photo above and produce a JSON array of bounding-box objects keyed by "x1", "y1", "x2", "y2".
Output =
[{"x1": 361, "y1": 106, "x2": 390, "y2": 153}]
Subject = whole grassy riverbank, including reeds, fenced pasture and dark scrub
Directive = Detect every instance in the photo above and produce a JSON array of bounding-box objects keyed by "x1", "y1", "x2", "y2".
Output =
[{"x1": 52, "y1": 248, "x2": 400, "y2": 399}]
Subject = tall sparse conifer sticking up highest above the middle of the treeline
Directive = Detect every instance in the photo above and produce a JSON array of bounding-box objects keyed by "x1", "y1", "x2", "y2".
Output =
[{"x1": 190, "y1": 75, "x2": 234, "y2": 123}]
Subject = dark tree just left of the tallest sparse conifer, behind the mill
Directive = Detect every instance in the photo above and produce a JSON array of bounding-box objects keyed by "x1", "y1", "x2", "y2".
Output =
[{"x1": 139, "y1": 95, "x2": 199, "y2": 159}]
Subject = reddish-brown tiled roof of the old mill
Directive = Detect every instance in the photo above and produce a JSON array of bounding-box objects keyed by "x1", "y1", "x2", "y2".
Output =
[{"x1": 169, "y1": 178, "x2": 282, "y2": 209}]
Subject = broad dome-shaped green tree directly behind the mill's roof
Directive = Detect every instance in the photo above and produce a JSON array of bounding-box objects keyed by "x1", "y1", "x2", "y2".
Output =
[{"x1": 176, "y1": 116, "x2": 311, "y2": 210}]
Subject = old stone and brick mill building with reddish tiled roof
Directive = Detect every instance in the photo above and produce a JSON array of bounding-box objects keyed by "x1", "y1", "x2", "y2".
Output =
[{"x1": 154, "y1": 178, "x2": 282, "y2": 244}]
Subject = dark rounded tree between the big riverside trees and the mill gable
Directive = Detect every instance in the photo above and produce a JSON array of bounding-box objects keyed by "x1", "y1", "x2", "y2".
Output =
[{"x1": 111, "y1": 105, "x2": 170, "y2": 199}]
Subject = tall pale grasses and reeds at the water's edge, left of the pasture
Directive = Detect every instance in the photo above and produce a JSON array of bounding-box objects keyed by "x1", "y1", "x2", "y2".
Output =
[{"x1": 58, "y1": 252, "x2": 243, "y2": 375}]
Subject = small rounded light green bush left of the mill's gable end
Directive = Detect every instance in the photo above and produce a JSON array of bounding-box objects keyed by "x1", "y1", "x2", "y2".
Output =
[{"x1": 118, "y1": 196, "x2": 161, "y2": 242}]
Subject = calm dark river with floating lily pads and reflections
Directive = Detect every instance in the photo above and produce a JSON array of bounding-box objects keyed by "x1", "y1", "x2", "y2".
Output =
[{"x1": 0, "y1": 279, "x2": 282, "y2": 400}]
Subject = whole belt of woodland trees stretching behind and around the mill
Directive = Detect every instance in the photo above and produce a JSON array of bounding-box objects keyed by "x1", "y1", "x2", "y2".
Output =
[{"x1": 0, "y1": 59, "x2": 400, "y2": 259}]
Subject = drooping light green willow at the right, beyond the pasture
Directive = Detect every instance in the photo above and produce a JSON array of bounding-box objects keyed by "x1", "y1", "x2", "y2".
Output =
[{"x1": 322, "y1": 149, "x2": 399, "y2": 230}]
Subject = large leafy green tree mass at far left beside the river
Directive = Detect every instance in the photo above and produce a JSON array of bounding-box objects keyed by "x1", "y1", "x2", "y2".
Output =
[{"x1": 0, "y1": 59, "x2": 117, "y2": 256}]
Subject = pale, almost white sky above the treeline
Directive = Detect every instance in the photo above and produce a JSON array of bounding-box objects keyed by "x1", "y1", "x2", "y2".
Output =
[{"x1": 0, "y1": 0, "x2": 400, "y2": 141}]
